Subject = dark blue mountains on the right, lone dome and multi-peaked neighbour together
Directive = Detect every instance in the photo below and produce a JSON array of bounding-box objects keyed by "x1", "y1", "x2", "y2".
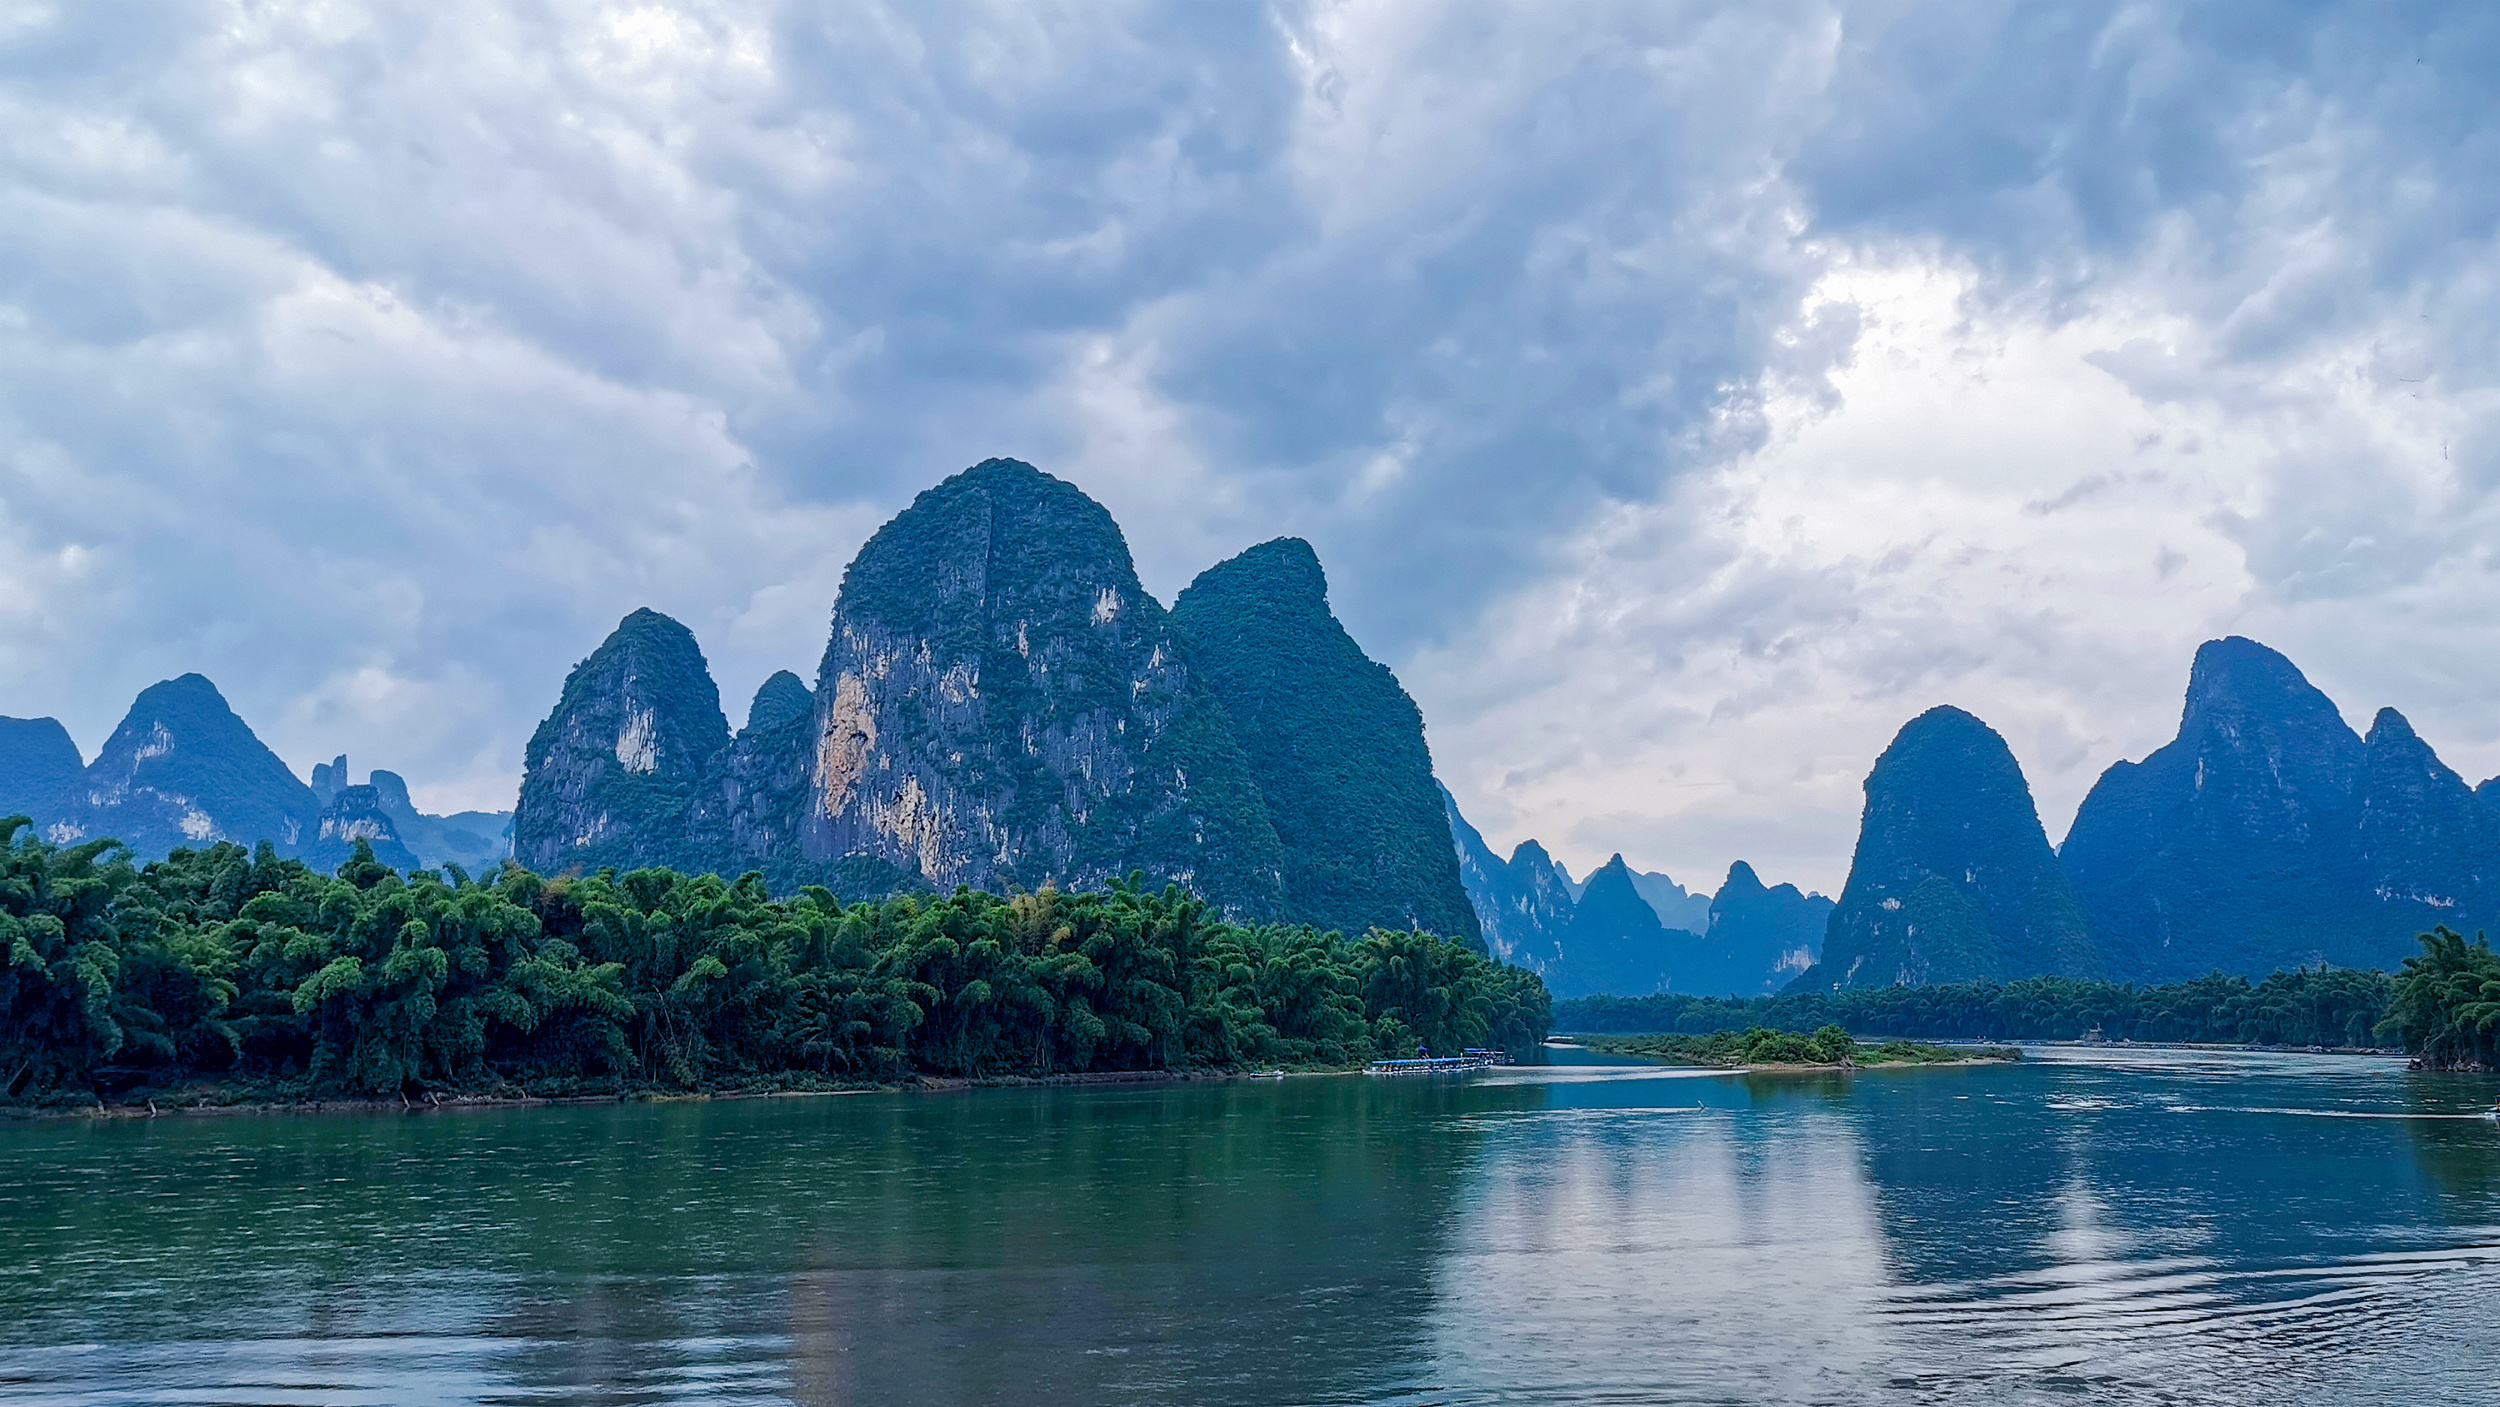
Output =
[{"x1": 1798, "y1": 635, "x2": 2500, "y2": 990}]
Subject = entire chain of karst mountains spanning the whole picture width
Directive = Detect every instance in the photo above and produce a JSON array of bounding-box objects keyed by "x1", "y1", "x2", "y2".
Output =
[{"x1": 0, "y1": 460, "x2": 2500, "y2": 997}]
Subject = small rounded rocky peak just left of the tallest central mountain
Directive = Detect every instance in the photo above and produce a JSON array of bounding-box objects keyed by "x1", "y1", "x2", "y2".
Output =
[{"x1": 513, "y1": 610, "x2": 730, "y2": 875}]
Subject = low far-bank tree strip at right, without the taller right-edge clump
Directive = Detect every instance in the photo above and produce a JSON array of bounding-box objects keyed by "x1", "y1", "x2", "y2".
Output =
[{"x1": 1555, "y1": 967, "x2": 2393, "y2": 1045}]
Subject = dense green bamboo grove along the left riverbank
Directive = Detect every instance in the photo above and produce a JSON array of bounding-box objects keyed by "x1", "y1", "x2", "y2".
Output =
[{"x1": 0, "y1": 817, "x2": 1550, "y2": 1105}]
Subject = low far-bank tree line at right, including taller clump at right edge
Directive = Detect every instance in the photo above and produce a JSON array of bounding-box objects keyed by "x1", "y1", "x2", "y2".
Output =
[{"x1": 1553, "y1": 927, "x2": 2500, "y2": 1070}]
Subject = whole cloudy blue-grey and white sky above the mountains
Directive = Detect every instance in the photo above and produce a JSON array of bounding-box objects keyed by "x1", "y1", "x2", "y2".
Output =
[{"x1": 0, "y1": 0, "x2": 2500, "y2": 890}]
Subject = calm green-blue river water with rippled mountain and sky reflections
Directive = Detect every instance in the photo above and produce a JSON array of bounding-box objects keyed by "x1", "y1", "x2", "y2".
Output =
[{"x1": 0, "y1": 1050, "x2": 2500, "y2": 1407}]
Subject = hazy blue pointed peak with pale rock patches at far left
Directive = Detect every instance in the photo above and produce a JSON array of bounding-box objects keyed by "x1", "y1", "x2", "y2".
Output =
[{"x1": 48, "y1": 675, "x2": 320, "y2": 860}]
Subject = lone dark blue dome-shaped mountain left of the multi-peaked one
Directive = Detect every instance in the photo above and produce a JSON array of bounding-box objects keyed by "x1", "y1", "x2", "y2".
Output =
[{"x1": 1795, "y1": 707, "x2": 2103, "y2": 990}]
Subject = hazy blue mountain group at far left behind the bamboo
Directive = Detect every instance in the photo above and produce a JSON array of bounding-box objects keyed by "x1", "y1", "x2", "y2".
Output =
[{"x1": 0, "y1": 675, "x2": 510, "y2": 870}]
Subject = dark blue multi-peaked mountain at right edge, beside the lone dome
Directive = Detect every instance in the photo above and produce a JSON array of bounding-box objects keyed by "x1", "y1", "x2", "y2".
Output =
[{"x1": 2060, "y1": 637, "x2": 2500, "y2": 982}]
